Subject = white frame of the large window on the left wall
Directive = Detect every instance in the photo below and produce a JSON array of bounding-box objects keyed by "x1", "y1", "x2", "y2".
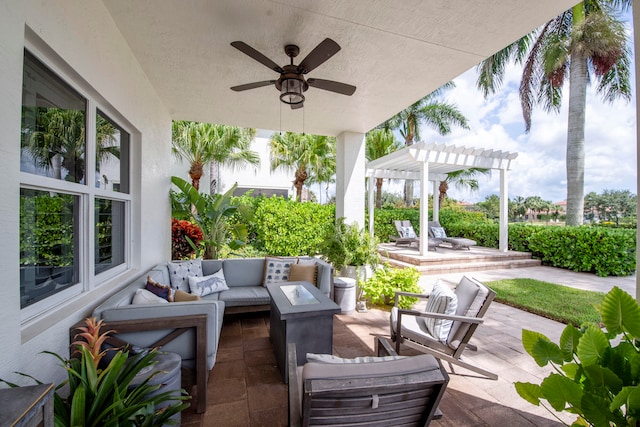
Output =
[{"x1": 16, "y1": 44, "x2": 136, "y2": 325}]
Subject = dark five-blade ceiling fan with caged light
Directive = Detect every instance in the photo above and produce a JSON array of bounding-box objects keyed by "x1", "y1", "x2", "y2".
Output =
[{"x1": 231, "y1": 38, "x2": 356, "y2": 109}]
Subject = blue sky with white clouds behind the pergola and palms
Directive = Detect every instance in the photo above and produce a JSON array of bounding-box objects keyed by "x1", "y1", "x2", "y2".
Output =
[{"x1": 412, "y1": 24, "x2": 637, "y2": 206}]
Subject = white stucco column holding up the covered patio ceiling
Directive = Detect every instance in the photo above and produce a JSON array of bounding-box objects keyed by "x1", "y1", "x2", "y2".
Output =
[{"x1": 336, "y1": 132, "x2": 365, "y2": 227}]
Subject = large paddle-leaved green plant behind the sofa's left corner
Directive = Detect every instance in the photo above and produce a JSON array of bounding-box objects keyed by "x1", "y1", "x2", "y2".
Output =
[{"x1": 171, "y1": 176, "x2": 251, "y2": 259}]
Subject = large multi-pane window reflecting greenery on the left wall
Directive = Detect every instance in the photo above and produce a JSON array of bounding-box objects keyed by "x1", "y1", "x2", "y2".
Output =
[{"x1": 20, "y1": 50, "x2": 130, "y2": 317}]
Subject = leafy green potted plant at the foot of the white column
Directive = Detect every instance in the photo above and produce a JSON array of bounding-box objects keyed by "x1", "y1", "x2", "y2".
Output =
[{"x1": 320, "y1": 218, "x2": 380, "y2": 311}]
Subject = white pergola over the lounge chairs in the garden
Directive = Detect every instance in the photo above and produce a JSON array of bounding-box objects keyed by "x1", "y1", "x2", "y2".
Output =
[{"x1": 366, "y1": 142, "x2": 518, "y2": 256}]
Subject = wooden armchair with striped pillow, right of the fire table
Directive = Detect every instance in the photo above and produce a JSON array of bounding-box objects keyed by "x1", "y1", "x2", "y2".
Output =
[{"x1": 390, "y1": 276, "x2": 498, "y2": 380}]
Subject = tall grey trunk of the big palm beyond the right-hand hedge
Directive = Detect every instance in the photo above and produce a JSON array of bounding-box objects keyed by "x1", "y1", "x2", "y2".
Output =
[{"x1": 567, "y1": 51, "x2": 587, "y2": 225}]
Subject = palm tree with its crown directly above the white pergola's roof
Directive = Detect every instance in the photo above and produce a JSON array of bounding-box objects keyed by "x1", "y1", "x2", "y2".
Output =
[{"x1": 381, "y1": 82, "x2": 469, "y2": 206}]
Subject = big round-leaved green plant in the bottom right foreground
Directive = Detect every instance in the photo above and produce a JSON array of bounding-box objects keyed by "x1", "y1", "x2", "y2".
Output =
[{"x1": 515, "y1": 287, "x2": 640, "y2": 426}]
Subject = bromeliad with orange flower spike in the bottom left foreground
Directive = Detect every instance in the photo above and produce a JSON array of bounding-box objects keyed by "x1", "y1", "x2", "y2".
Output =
[{"x1": 0, "y1": 318, "x2": 190, "y2": 427}]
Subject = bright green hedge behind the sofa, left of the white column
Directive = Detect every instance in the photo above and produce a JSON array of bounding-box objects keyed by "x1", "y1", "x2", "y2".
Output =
[{"x1": 254, "y1": 197, "x2": 335, "y2": 256}]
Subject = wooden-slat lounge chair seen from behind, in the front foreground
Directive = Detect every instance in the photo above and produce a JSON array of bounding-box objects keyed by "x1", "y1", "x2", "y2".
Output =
[{"x1": 288, "y1": 343, "x2": 449, "y2": 427}]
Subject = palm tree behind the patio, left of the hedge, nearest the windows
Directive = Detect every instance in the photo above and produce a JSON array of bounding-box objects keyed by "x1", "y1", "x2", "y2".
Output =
[{"x1": 171, "y1": 120, "x2": 260, "y2": 194}]
